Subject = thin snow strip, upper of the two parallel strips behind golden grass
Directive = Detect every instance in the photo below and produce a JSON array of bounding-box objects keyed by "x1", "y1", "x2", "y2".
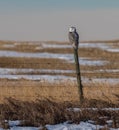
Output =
[{"x1": 0, "y1": 68, "x2": 119, "y2": 75}]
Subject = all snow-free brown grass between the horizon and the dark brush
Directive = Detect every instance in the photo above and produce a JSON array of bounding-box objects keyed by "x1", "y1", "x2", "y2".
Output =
[{"x1": 0, "y1": 41, "x2": 119, "y2": 102}]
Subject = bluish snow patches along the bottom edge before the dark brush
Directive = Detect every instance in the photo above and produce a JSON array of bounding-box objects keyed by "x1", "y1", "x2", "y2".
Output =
[{"x1": 0, "y1": 120, "x2": 119, "y2": 130}]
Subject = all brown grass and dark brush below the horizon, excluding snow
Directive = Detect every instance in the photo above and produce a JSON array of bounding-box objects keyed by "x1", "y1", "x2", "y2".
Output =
[{"x1": 0, "y1": 41, "x2": 119, "y2": 127}]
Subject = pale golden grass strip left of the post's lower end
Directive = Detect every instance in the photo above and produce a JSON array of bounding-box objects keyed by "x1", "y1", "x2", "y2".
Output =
[{"x1": 0, "y1": 80, "x2": 78, "y2": 102}]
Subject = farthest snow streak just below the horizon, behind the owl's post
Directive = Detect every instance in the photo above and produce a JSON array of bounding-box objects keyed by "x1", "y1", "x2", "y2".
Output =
[{"x1": 2, "y1": 42, "x2": 119, "y2": 52}]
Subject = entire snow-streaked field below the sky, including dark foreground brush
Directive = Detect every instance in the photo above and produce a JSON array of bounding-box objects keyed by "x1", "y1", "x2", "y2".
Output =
[{"x1": 0, "y1": 41, "x2": 119, "y2": 128}]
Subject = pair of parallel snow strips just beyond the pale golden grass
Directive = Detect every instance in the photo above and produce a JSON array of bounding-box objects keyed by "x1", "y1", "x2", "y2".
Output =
[{"x1": 0, "y1": 68, "x2": 119, "y2": 84}]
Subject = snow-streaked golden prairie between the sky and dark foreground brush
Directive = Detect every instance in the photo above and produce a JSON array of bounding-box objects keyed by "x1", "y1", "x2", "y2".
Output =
[{"x1": 0, "y1": 41, "x2": 119, "y2": 102}]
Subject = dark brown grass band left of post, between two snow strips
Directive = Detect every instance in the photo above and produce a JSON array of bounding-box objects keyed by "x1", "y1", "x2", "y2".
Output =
[{"x1": 0, "y1": 57, "x2": 73, "y2": 69}]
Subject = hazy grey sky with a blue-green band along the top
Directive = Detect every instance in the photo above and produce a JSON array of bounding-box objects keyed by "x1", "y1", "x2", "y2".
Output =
[{"x1": 0, "y1": 0, "x2": 119, "y2": 41}]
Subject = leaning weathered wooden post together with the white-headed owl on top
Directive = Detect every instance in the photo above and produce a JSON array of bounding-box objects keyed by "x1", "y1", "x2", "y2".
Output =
[{"x1": 68, "y1": 27, "x2": 84, "y2": 103}]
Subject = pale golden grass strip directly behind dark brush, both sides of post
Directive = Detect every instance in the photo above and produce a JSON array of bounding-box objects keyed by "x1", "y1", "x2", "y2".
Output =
[{"x1": 0, "y1": 79, "x2": 119, "y2": 103}]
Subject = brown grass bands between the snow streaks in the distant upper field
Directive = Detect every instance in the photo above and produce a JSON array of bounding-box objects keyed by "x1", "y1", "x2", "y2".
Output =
[{"x1": 0, "y1": 41, "x2": 119, "y2": 72}]
